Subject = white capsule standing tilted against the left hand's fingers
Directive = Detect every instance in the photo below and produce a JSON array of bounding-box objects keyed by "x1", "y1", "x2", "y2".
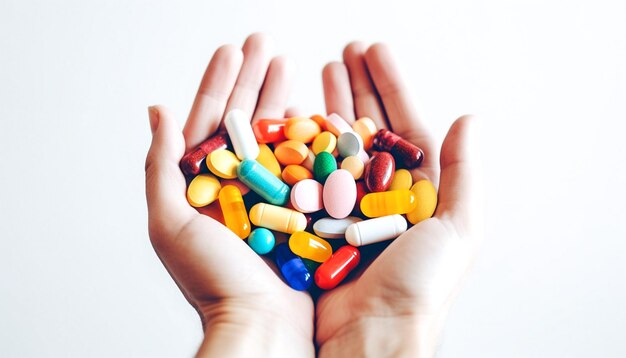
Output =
[{"x1": 224, "y1": 109, "x2": 260, "y2": 160}]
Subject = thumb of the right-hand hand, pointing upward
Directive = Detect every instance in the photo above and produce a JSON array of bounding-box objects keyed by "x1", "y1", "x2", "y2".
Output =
[{"x1": 435, "y1": 116, "x2": 482, "y2": 238}]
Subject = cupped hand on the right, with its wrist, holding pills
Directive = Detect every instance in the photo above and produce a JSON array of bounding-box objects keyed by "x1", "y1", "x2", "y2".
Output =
[{"x1": 316, "y1": 43, "x2": 482, "y2": 357}]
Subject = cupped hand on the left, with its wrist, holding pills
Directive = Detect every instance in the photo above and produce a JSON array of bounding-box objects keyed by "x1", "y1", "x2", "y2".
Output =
[{"x1": 146, "y1": 34, "x2": 314, "y2": 356}]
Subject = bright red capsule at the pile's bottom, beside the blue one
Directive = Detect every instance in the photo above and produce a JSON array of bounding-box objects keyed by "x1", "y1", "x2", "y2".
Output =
[{"x1": 314, "y1": 245, "x2": 361, "y2": 290}]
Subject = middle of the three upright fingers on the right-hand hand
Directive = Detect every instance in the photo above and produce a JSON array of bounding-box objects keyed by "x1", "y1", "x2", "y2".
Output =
[{"x1": 343, "y1": 42, "x2": 388, "y2": 128}]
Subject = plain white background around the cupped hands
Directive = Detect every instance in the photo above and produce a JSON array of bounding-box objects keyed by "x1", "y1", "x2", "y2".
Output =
[{"x1": 0, "y1": 0, "x2": 626, "y2": 357}]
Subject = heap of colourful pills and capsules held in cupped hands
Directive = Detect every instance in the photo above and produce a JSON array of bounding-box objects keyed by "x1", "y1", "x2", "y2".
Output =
[{"x1": 180, "y1": 110, "x2": 437, "y2": 290}]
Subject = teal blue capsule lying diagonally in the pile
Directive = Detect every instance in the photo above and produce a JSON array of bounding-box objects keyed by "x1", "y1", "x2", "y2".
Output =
[{"x1": 237, "y1": 159, "x2": 290, "y2": 205}]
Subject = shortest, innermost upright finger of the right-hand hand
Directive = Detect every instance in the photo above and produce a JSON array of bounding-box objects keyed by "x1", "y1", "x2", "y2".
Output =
[{"x1": 322, "y1": 62, "x2": 354, "y2": 123}]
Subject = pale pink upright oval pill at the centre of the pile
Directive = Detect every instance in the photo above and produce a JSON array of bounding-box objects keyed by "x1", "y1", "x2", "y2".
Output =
[{"x1": 322, "y1": 169, "x2": 356, "y2": 219}]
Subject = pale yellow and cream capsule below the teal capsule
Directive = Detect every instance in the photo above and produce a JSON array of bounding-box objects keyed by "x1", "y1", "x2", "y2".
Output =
[{"x1": 250, "y1": 203, "x2": 307, "y2": 234}]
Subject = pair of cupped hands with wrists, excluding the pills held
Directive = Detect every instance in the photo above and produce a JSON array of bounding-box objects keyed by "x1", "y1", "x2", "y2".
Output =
[{"x1": 145, "y1": 34, "x2": 482, "y2": 357}]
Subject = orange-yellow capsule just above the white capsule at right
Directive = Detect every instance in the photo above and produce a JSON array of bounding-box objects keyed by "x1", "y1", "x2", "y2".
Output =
[{"x1": 361, "y1": 189, "x2": 417, "y2": 218}]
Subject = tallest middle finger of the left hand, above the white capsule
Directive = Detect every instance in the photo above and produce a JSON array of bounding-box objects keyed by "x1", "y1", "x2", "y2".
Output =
[{"x1": 226, "y1": 33, "x2": 272, "y2": 119}]
